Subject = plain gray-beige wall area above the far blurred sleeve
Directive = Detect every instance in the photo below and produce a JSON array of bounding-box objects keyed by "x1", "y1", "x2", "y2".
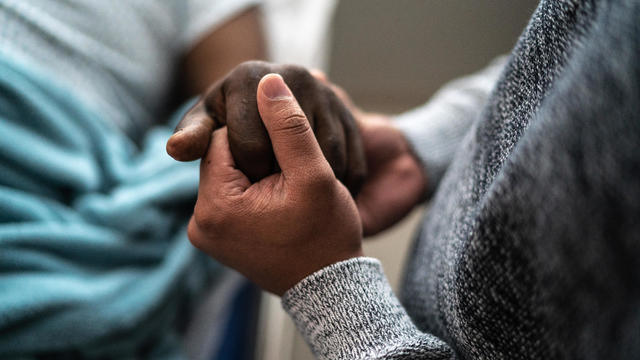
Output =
[{"x1": 330, "y1": 0, "x2": 537, "y2": 111}]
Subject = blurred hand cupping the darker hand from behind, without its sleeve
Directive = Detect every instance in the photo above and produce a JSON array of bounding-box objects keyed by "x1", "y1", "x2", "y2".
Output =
[{"x1": 313, "y1": 72, "x2": 427, "y2": 236}]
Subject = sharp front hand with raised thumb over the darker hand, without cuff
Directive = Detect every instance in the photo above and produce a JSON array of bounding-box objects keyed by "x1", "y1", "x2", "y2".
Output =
[{"x1": 188, "y1": 75, "x2": 362, "y2": 295}]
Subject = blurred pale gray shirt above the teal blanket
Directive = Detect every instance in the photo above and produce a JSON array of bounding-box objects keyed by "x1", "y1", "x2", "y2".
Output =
[{"x1": 0, "y1": 0, "x2": 259, "y2": 138}]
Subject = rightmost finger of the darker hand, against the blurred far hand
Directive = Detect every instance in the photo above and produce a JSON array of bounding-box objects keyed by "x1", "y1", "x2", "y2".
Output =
[{"x1": 330, "y1": 91, "x2": 367, "y2": 197}]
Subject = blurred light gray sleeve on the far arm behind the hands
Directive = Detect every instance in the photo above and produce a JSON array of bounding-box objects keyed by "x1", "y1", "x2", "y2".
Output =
[{"x1": 395, "y1": 56, "x2": 507, "y2": 192}]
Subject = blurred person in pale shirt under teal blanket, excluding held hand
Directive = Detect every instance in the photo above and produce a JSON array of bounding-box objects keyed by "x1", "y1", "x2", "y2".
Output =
[{"x1": 0, "y1": 0, "x2": 262, "y2": 359}]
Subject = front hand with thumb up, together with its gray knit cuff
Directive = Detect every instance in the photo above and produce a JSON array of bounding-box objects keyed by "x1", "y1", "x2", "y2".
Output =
[{"x1": 188, "y1": 75, "x2": 451, "y2": 359}]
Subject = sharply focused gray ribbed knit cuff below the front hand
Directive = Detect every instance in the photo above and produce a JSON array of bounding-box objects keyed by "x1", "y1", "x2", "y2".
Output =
[{"x1": 282, "y1": 257, "x2": 453, "y2": 360}]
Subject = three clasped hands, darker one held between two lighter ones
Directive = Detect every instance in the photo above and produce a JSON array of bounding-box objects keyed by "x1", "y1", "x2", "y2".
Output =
[{"x1": 167, "y1": 62, "x2": 426, "y2": 294}]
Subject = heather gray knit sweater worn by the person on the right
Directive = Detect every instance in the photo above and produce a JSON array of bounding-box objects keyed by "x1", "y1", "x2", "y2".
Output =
[{"x1": 283, "y1": 0, "x2": 640, "y2": 359}]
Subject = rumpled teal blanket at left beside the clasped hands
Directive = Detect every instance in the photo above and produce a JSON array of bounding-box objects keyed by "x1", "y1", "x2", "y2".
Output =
[{"x1": 0, "y1": 52, "x2": 214, "y2": 359}]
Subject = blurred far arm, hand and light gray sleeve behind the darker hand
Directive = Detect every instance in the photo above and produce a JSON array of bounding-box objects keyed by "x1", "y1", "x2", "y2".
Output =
[{"x1": 315, "y1": 58, "x2": 506, "y2": 236}]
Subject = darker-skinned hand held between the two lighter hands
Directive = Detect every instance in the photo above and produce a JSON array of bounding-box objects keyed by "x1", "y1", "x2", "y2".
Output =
[{"x1": 167, "y1": 61, "x2": 366, "y2": 194}]
